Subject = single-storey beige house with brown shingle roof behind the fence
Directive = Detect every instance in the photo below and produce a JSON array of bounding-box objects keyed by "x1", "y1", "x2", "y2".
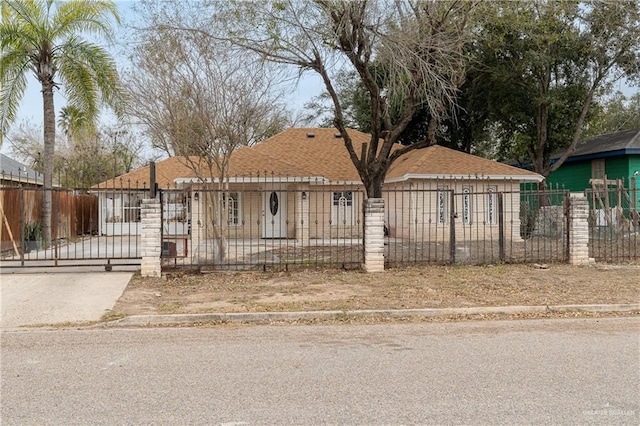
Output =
[{"x1": 94, "y1": 128, "x2": 543, "y2": 241}]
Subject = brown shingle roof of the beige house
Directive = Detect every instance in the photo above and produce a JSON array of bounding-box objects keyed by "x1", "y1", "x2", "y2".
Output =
[{"x1": 96, "y1": 128, "x2": 542, "y2": 187}]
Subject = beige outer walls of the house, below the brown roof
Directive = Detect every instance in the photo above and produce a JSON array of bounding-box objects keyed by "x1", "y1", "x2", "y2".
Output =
[{"x1": 192, "y1": 179, "x2": 520, "y2": 241}]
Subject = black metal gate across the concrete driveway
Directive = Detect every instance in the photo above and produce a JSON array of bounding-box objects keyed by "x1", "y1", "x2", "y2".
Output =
[{"x1": 0, "y1": 187, "x2": 149, "y2": 270}]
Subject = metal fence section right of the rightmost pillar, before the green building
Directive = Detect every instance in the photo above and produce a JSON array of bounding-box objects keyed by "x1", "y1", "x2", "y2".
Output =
[{"x1": 585, "y1": 178, "x2": 640, "y2": 262}]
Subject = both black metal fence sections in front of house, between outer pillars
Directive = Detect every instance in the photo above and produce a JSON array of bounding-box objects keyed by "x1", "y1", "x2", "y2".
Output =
[{"x1": 161, "y1": 174, "x2": 568, "y2": 270}]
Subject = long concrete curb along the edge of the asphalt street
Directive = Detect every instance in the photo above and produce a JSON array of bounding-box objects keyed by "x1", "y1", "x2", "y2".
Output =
[{"x1": 102, "y1": 303, "x2": 640, "y2": 327}]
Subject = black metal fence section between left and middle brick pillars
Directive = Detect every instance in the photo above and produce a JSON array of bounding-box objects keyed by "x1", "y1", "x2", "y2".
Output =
[{"x1": 160, "y1": 174, "x2": 364, "y2": 270}]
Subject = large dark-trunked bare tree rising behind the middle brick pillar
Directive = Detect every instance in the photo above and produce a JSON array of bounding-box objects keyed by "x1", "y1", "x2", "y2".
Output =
[{"x1": 166, "y1": 0, "x2": 475, "y2": 198}]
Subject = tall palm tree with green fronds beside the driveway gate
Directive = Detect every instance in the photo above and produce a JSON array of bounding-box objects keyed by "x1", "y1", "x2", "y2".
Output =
[{"x1": 0, "y1": 0, "x2": 123, "y2": 244}]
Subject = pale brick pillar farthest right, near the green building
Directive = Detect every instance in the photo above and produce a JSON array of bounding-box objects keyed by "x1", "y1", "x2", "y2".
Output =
[{"x1": 568, "y1": 194, "x2": 590, "y2": 265}]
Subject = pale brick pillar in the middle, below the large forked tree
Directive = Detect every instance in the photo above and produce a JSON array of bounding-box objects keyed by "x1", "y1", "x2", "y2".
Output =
[{"x1": 364, "y1": 198, "x2": 384, "y2": 272}]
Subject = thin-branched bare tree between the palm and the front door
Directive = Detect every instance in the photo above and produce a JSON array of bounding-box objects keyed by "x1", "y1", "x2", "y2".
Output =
[{"x1": 125, "y1": 8, "x2": 291, "y2": 260}]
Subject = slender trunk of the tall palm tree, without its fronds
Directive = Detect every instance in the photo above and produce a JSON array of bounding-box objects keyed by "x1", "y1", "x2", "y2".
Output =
[{"x1": 42, "y1": 81, "x2": 56, "y2": 247}]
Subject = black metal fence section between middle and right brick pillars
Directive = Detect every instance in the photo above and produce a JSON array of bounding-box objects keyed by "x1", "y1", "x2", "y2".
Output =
[{"x1": 385, "y1": 178, "x2": 568, "y2": 264}]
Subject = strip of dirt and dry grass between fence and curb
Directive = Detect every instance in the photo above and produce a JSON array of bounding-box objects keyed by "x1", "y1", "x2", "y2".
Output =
[{"x1": 112, "y1": 264, "x2": 640, "y2": 315}]
